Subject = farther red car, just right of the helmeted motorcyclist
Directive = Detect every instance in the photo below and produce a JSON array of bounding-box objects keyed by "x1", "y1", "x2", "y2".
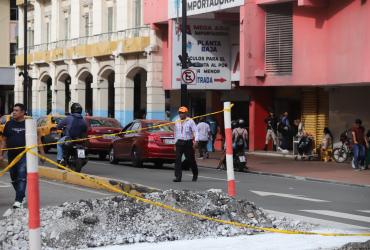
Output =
[{"x1": 85, "y1": 116, "x2": 122, "y2": 160}]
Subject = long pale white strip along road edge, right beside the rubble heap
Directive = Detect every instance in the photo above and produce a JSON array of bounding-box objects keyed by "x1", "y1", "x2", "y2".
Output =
[{"x1": 263, "y1": 209, "x2": 369, "y2": 232}]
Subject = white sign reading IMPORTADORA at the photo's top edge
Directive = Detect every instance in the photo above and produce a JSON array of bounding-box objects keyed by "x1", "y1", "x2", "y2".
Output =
[{"x1": 168, "y1": 0, "x2": 244, "y2": 19}]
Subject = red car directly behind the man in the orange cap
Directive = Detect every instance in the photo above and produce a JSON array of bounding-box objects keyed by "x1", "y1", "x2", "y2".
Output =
[{"x1": 109, "y1": 120, "x2": 176, "y2": 167}]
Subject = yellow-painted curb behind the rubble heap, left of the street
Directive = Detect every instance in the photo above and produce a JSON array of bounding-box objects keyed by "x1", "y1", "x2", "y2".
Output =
[{"x1": 39, "y1": 166, "x2": 160, "y2": 196}]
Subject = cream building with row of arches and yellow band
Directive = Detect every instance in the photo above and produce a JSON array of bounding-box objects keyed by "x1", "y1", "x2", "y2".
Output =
[{"x1": 14, "y1": 0, "x2": 165, "y2": 125}]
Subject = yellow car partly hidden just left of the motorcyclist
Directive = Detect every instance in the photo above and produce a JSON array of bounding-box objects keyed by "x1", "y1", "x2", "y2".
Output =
[{"x1": 37, "y1": 115, "x2": 65, "y2": 153}]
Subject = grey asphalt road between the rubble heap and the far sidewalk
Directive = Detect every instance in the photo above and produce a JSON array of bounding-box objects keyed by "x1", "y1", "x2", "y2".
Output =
[{"x1": 36, "y1": 150, "x2": 370, "y2": 229}]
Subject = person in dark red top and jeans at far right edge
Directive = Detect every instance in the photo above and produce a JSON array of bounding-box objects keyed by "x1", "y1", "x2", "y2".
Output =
[{"x1": 352, "y1": 119, "x2": 369, "y2": 170}]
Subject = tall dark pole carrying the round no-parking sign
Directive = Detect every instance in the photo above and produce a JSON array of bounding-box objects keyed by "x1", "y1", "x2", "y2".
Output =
[{"x1": 181, "y1": 0, "x2": 188, "y2": 106}]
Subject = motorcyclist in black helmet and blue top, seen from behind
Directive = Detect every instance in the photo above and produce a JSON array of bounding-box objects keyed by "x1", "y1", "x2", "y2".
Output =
[{"x1": 57, "y1": 103, "x2": 87, "y2": 164}]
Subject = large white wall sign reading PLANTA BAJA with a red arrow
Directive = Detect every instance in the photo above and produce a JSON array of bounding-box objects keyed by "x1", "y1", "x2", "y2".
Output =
[{"x1": 172, "y1": 19, "x2": 231, "y2": 89}]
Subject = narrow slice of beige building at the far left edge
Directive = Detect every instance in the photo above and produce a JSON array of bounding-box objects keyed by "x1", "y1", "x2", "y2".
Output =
[{"x1": 0, "y1": 0, "x2": 18, "y2": 115}]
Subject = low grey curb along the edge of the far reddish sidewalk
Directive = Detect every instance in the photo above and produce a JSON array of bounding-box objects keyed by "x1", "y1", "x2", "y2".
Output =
[{"x1": 198, "y1": 165, "x2": 370, "y2": 188}]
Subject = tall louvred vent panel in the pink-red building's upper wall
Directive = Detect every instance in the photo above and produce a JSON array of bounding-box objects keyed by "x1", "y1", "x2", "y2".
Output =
[{"x1": 265, "y1": 3, "x2": 293, "y2": 75}]
